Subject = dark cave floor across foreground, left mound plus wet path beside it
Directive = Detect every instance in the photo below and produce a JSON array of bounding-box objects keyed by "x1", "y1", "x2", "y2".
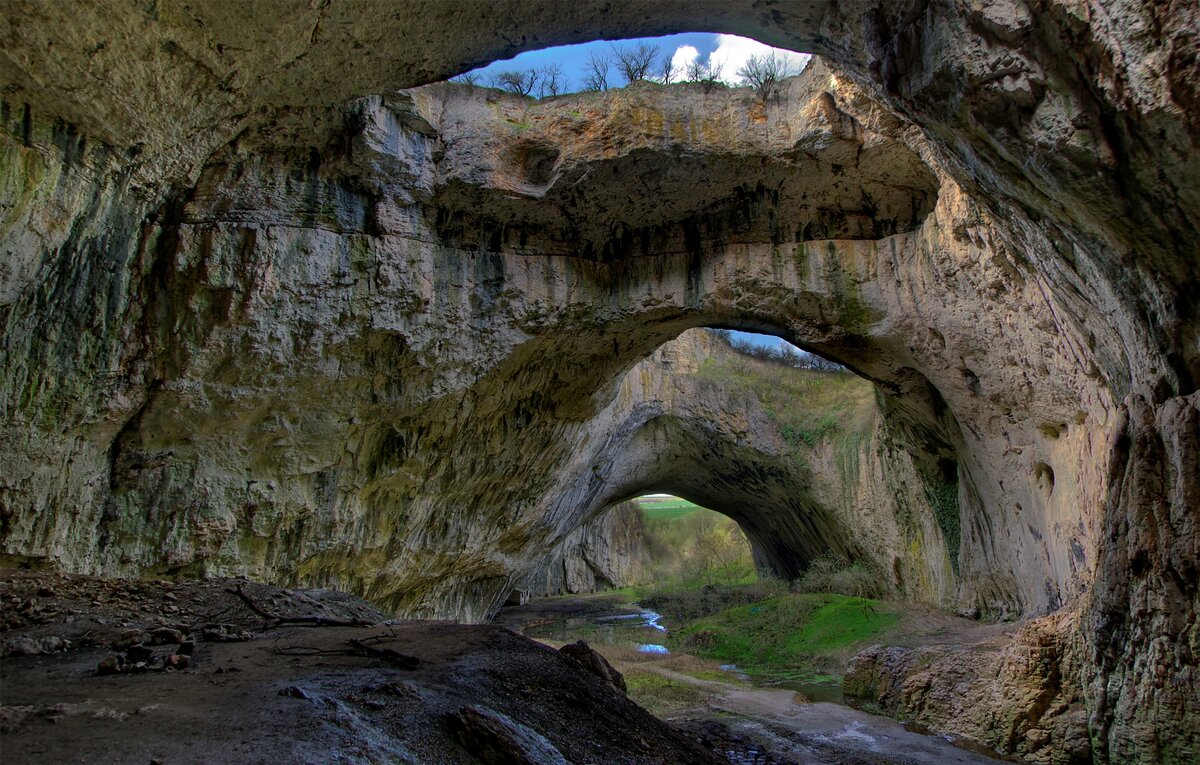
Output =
[{"x1": 0, "y1": 571, "x2": 1022, "y2": 765}]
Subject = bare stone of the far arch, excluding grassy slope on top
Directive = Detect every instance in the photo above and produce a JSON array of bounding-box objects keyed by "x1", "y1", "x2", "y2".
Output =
[{"x1": 535, "y1": 330, "x2": 955, "y2": 602}]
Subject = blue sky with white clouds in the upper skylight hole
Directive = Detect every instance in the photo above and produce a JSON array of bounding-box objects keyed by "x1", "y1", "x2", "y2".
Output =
[{"x1": 463, "y1": 32, "x2": 809, "y2": 91}]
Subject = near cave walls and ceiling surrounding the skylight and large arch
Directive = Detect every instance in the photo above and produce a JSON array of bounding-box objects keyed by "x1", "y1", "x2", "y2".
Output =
[{"x1": 0, "y1": 0, "x2": 1200, "y2": 763}]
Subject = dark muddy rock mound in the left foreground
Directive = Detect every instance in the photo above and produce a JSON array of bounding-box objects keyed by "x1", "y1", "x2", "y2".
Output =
[{"x1": 0, "y1": 570, "x2": 721, "y2": 765}]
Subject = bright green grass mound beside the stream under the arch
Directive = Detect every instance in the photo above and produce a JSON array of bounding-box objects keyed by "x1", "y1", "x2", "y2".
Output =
[{"x1": 670, "y1": 594, "x2": 898, "y2": 676}]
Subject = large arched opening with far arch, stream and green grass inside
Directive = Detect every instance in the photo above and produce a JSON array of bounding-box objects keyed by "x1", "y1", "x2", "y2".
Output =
[{"x1": 498, "y1": 317, "x2": 960, "y2": 714}]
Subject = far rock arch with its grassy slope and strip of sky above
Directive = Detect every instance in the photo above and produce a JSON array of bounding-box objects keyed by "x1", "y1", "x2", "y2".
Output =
[{"x1": 535, "y1": 320, "x2": 961, "y2": 602}]
